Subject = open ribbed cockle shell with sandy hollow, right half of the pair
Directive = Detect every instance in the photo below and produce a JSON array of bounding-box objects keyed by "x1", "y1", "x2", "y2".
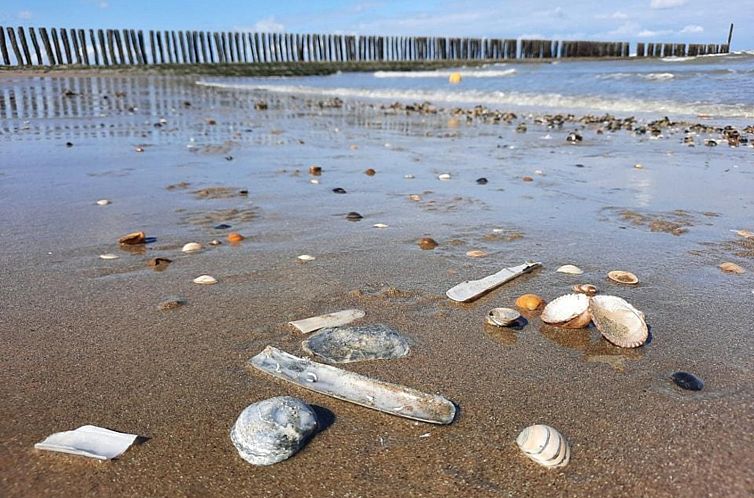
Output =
[{"x1": 589, "y1": 296, "x2": 649, "y2": 348}]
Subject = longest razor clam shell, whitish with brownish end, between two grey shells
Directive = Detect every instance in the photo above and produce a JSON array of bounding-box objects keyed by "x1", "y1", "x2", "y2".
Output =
[{"x1": 249, "y1": 346, "x2": 456, "y2": 424}]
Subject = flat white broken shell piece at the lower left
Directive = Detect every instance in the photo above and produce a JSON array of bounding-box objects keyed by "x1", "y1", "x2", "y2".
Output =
[{"x1": 34, "y1": 425, "x2": 138, "y2": 460}]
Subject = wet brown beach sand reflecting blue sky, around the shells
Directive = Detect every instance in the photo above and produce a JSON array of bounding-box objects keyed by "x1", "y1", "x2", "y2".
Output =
[{"x1": 0, "y1": 76, "x2": 754, "y2": 496}]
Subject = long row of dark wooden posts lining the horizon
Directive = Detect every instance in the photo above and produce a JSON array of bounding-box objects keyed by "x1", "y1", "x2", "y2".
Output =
[{"x1": 0, "y1": 26, "x2": 728, "y2": 66}]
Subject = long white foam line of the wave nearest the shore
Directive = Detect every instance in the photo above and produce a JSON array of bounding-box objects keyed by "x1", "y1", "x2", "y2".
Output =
[{"x1": 197, "y1": 81, "x2": 754, "y2": 118}]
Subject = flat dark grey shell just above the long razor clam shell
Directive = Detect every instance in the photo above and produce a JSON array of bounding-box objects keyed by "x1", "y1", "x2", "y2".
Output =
[{"x1": 302, "y1": 324, "x2": 409, "y2": 363}]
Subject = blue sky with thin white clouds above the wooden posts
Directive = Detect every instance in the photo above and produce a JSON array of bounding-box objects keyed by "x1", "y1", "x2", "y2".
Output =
[{"x1": 0, "y1": 0, "x2": 754, "y2": 50}]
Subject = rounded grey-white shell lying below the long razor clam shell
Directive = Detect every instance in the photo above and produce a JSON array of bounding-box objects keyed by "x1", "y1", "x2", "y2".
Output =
[{"x1": 230, "y1": 396, "x2": 317, "y2": 465}]
